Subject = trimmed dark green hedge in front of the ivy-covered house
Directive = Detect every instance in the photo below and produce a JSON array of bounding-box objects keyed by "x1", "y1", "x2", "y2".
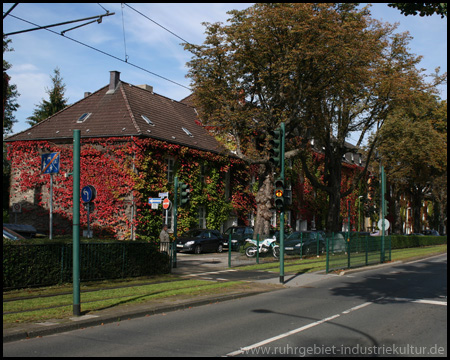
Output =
[{"x1": 3, "y1": 241, "x2": 170, "y2": 290}]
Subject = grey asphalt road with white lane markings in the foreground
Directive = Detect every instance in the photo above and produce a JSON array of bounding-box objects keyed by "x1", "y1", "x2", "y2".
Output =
[{"x1": 3, "y1": 254, "x2": 447, "y2": 357}]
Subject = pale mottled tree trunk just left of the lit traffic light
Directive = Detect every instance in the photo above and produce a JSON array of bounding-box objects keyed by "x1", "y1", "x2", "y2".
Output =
[{"x1": 254, "y1": 169, "x2": 273, "y2": 238}]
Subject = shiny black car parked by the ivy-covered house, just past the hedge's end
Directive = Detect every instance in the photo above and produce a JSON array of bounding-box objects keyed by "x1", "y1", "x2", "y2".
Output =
[{"x1": 177, "y1": 229, "x2": 224, "y2": 254}]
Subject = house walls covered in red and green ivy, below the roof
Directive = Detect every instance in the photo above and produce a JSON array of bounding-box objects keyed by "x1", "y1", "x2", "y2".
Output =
[{"x1": 8, "y1": 137, "x2": 254, "y2": 240}]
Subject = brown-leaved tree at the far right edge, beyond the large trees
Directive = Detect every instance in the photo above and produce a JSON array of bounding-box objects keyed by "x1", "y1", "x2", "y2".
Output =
[{"x1": 378, "y1": 93, "x2": 447, "y2": 232}]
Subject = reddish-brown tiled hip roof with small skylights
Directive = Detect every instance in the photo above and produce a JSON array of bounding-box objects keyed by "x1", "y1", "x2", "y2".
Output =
[{"x1": 5, "y1": 78, "x2": 225, "y2": 153}]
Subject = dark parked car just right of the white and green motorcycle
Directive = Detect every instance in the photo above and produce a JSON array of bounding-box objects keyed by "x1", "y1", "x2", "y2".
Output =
[{"x1": 284, "y1": 231, "x2": 326, "y2": 255}]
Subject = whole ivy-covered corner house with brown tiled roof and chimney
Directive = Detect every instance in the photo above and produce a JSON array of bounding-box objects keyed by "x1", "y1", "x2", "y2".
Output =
[{"x1": 5, "y1": 71, "x2": 252, "y2": 239}]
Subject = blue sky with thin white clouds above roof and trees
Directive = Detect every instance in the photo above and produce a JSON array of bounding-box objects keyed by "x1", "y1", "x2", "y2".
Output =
[{"x1": 3, "y1": 3, "x2": 447, "y2": 143}]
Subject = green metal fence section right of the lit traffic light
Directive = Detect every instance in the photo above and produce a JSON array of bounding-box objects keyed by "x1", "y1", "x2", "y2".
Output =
[{"x1": 326, "y1": 233, "x2": 391, "y2": 273}]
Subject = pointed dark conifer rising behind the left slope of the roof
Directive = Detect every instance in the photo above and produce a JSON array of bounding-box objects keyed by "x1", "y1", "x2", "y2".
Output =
[{"x1": 27, "y1": 68, "x2": 68, "y2": 126}]
